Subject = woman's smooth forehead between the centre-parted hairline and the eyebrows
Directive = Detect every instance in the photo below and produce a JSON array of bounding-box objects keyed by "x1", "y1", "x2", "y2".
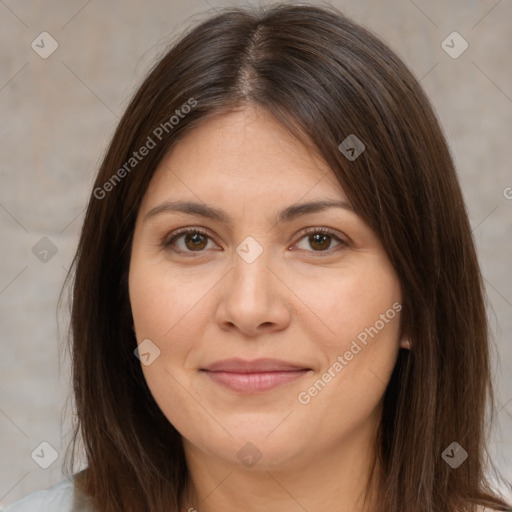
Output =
[{"x1": 142, "y1": 107, "x2": 345, "y2": 206}]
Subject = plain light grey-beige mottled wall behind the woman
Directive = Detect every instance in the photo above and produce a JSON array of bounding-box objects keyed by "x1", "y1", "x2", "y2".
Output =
[{"x1": 0, "y1": 0, "x2": 512, "y2": 510}]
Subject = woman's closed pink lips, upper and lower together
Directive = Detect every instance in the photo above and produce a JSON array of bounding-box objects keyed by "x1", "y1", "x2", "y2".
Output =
[{"x1": 202, "y1": 358, "x2": 311, "y2": 393}]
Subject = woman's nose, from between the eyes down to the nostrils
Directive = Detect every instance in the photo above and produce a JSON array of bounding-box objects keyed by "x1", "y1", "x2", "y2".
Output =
[{"x1": 216, "y1": 246, "x2": 292, "y2": 337}]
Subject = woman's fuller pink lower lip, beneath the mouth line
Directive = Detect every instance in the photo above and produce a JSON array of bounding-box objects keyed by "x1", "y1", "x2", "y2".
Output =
[{"x1": 204, "y1": 370, "x2": 310, "y2": 393}]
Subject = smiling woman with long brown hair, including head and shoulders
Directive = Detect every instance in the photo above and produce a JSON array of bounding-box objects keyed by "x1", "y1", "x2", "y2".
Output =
[{"x1": 8, "y1": 5, "x2": 510, "y2": 512}]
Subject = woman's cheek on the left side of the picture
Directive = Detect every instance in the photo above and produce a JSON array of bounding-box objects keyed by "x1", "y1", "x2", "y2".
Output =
[{"x1": 129, "y1": 258, "x2": 218, "y2": 394}]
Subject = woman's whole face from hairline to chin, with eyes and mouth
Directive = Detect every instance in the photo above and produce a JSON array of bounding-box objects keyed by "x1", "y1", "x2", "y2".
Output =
[{"x1": 129, "y1": 108, "x2": 401, "y2": 468}]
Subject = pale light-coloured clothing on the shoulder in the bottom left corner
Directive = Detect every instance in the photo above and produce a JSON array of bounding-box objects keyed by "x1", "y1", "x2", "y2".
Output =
[{"x1": 4, "y1": 480, "x2": 74, "y2": 512}]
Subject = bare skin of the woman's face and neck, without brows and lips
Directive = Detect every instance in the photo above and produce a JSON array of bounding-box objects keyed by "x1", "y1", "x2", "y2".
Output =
[{"x1": 129, "y1": 107, "x2": 407, "y2": 512}]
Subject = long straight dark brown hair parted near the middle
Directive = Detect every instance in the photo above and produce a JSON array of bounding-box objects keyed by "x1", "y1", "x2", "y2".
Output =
[{"x1": 61, "y1": 4, "x2": 510, "y2": 512}]
